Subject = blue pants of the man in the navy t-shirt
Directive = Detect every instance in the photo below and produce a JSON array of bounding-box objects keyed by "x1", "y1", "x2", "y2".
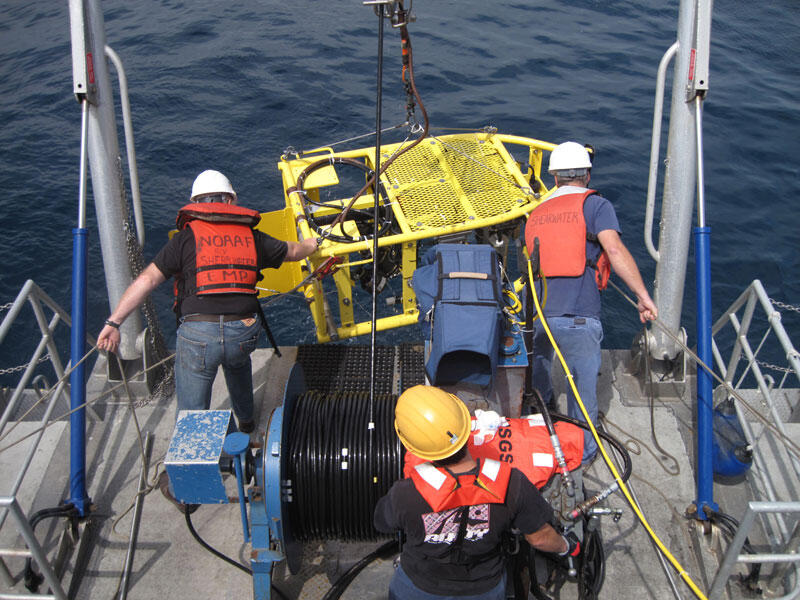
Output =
[{"x1": 533, "y1": 317, "x2": 603, "y2": 462}]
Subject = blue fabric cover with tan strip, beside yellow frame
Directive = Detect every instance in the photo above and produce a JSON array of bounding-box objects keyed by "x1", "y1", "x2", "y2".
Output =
[{"x1": 411, "y1": 244, "x2": 502, "y2": 387}]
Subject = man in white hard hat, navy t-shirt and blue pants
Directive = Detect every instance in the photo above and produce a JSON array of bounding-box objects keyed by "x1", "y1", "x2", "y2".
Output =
[{"x1": 525, "y1": 142, "x2": 658, "y2": 463}]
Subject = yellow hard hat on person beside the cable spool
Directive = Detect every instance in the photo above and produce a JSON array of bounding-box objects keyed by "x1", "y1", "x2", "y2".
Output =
[{"x1": 394, "y1": 385, "x2": 471, "y2": 460}]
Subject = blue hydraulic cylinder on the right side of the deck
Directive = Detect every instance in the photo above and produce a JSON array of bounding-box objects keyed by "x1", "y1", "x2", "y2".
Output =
[{"x1": 693, "y1": 227, "x2": 719, "y2": 520}]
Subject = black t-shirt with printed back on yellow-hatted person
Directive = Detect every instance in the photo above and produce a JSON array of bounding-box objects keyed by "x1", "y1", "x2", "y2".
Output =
[{"x1": 374, "y1": 469, "x2": 553, "y2": 596}]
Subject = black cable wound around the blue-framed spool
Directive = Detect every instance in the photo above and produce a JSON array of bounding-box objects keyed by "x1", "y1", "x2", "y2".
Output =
[{"x1": 286, "y1": 391, "x2": 402, "y2": 542}]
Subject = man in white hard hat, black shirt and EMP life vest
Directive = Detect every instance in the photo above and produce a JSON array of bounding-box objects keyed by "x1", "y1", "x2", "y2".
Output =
[{"x1": 97, "y1": 170, "x2": 318, "y2": 433}]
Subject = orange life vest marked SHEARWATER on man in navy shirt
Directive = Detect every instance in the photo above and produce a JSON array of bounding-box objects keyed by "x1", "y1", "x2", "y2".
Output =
[{"x1": 525, "y1": 190, "x2": 611, "y2": 290}]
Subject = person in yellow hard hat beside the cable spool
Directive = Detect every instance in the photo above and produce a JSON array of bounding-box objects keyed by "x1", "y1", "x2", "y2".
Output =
[{"x1": 374, "y1": 385, "x2": 580, "y2": 600}]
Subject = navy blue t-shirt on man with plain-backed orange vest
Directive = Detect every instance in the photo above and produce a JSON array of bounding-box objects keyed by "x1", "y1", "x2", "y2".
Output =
[{"x1": 537, "y1": 186, "x2": 620, "y2": 319}]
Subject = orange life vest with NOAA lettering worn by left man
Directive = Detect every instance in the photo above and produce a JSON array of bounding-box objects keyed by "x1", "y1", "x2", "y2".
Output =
[{"x1": 176, "y1": 202, "x2": 261, "y2": 296}]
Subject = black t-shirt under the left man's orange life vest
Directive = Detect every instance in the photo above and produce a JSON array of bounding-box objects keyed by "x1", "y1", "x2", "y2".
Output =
[{"x1": 153, "y1": 227, "x2": 289, "y2": 317}]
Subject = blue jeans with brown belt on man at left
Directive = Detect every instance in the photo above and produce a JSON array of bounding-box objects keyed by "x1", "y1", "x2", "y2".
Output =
[{"x1": 175, "y1": 318, "x2": 261, "y2": 423}]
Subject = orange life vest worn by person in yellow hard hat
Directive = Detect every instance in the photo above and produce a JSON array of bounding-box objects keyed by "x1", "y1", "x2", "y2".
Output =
[{"x1": 411, "y1": 458, "x2": 511, "y2": 512}]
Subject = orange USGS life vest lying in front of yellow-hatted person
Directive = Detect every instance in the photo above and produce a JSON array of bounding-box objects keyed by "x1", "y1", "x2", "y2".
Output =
[{"x1": 403, "y1": 414, "x2": 583, "y2": 490}]
